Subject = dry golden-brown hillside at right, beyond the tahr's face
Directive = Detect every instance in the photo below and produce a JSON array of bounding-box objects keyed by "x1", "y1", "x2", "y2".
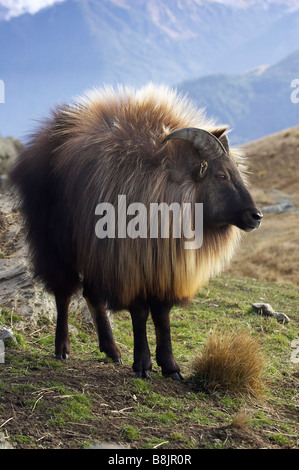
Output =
[{"x1": 230, "y1": 126, "x2": 299, "y2": 286}]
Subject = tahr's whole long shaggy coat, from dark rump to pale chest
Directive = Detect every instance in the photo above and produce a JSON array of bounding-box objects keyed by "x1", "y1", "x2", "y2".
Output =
[{"x1": 11, "y1": 84, "x2": 245, "y2": 308}]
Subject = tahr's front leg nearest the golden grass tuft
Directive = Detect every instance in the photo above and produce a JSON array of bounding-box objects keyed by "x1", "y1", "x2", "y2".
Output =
[{"x1": 150, "y1": 299, "x2": 183, "y2": 380}]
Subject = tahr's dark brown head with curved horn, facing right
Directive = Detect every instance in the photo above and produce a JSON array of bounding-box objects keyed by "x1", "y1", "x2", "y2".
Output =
[{"x1": 163, "y1": 127, "x2": 263, "y2": 232}]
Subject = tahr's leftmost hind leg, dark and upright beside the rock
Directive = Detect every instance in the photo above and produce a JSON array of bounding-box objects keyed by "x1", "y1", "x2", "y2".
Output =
[{"x1": 55, "y1": 293, "x2": 71, "y2": 359}]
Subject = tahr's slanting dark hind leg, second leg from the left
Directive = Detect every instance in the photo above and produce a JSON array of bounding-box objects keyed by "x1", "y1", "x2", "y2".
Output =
[{"x1": 83, "y1": 287, "x2": 122, "y2": 364}]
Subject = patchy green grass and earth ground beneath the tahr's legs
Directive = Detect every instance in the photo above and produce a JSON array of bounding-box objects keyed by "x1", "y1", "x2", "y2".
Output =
[{"x1": 0, "y1": 275, "x2": 299, "y2": 449}]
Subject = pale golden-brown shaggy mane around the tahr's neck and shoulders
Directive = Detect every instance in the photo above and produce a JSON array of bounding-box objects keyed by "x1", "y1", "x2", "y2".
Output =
[{"x1": 53, "y1": 85, "x2": 246, "y2": 308}]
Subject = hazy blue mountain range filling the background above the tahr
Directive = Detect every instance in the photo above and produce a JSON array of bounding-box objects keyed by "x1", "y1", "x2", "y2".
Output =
[{"x1": 0, "y1": 0, "x2": 299, "y2": 141}]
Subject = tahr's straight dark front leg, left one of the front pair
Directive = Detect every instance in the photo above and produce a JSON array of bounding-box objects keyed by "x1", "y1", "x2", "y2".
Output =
[{"x1": 129, "y1": 303, "x2": 152, "y2": 378}]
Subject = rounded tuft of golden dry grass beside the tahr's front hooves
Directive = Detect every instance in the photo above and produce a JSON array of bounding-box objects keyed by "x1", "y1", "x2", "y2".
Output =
[{"x1": 192, "y1": 331, "x2": 265, "y2": 396}]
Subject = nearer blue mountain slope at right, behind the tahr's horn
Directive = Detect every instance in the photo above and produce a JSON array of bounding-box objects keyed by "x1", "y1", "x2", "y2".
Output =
[{"x1": 177, "y1": 49, "x2": 299, "y2": 145}]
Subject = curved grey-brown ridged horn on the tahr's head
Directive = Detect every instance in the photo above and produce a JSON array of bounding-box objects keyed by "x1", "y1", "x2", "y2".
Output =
[{"x1": 162, "y1": 127, "x2": 227, "y2": 156}]
